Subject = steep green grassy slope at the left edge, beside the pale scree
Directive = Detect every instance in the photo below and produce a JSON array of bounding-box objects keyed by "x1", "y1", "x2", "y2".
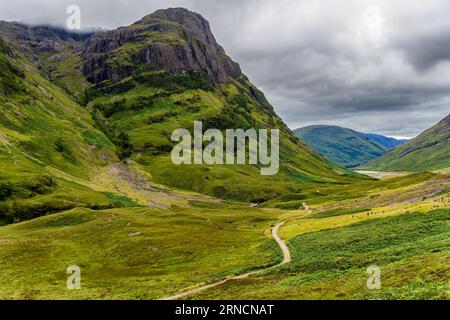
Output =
[{"x1": 0, "y1": 36, "x2": 132, "y2": 224}]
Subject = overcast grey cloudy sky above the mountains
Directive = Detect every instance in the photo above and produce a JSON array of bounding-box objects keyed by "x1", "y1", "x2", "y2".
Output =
[{"x1": 0, "y1": 0, "x2": 450, "y2": 137}]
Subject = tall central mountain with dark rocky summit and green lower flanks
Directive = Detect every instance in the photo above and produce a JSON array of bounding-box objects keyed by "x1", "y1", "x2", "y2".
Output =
[{"x1": 76, "y1": 8, "x2": 362, "y2": 202}]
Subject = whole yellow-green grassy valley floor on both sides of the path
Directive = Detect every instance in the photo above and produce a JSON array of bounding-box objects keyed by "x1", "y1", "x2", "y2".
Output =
[{"x1": 0, "y1": 168, "x2": 450, "y2": 299}]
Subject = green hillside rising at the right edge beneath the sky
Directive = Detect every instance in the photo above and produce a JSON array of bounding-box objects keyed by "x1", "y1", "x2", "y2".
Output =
[{"x1": 364, "y1": 115, "x2": 450, "y2": 172}]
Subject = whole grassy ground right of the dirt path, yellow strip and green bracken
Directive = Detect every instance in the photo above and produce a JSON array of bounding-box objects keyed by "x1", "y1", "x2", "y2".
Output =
[{"x1": 185, "y1": 173, "x2": 450, "y2": 299}]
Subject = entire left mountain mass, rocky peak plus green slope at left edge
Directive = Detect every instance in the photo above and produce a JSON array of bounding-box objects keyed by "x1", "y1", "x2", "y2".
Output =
[{"x1": 0, "y1": 8, "x2": 357, "y2": 222}]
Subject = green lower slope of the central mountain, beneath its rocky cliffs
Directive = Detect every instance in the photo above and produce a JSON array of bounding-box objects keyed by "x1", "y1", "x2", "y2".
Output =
[{"x1": 88, "y1": 77, "x2": 358, "y2": 202}]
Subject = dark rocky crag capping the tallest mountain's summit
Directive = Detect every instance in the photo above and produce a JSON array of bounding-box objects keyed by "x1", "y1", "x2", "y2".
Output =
[{"x1": 83, "y1": 8, "x2": 241, "y2": 83}]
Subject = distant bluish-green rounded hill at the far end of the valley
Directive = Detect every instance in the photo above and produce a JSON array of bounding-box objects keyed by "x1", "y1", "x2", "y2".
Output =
[{"x1": 294, "y1": 125, "x2": 406, "y2": 168}]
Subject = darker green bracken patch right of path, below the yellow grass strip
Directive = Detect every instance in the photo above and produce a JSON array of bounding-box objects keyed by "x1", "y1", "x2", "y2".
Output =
[{"x1": 193, "y1": 209, "x2": 450, "y2": 300}]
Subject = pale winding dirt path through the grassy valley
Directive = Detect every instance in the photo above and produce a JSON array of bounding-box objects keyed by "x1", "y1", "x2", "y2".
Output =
[{"x1": 161, "y1": 220, "x2": 291, "y2": 300}]
